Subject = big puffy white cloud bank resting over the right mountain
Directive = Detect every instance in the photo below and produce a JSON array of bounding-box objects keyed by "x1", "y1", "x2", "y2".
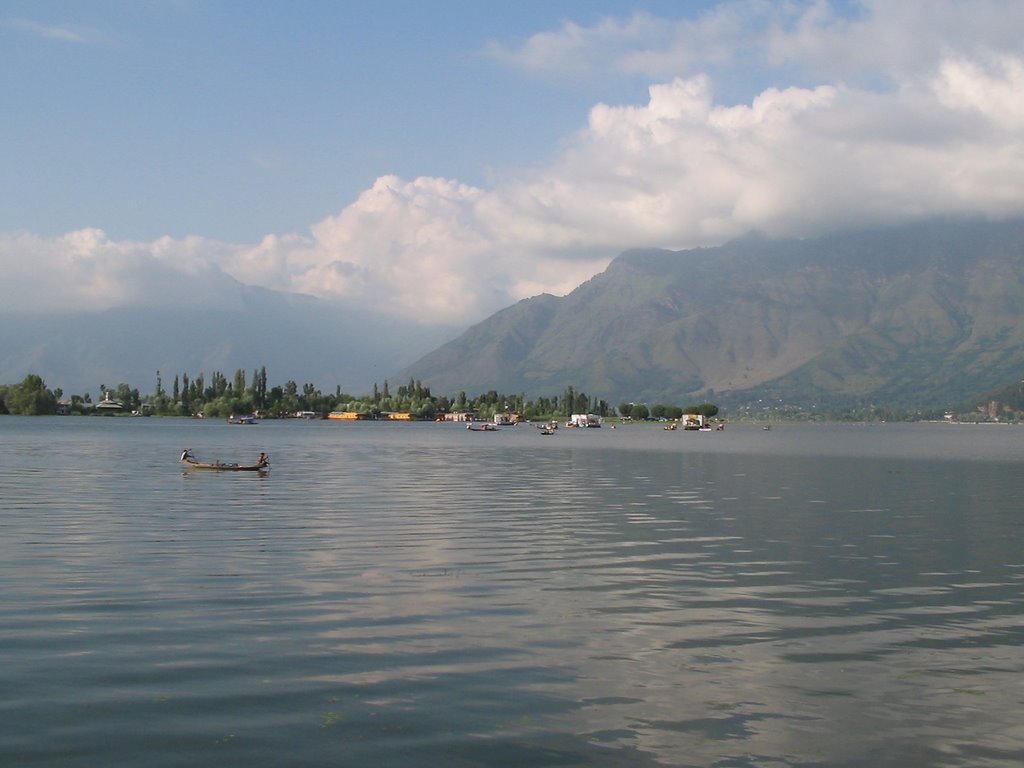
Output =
[{"x1": 223, "y1": 50, "x2": 1024, "y2": 323}]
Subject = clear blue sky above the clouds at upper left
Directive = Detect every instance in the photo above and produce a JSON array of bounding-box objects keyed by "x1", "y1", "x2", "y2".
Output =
[{"x1": 0, "y1": 0, "x2": 720, "y2": 242}]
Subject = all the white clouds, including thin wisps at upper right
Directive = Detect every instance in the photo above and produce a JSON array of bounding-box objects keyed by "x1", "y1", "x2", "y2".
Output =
[{"x1": 0, "y1": 0, "x2": 1024, "y2": 325}]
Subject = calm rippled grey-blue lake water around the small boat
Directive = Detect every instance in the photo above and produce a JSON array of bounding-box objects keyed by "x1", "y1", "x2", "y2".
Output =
[{"x1": 0, "y1": 417, "x2": 1024, "y2": 768}]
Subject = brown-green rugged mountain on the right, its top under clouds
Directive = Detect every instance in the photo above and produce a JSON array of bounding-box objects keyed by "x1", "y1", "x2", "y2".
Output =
[{"x1": 393, "y1": 221, "x2": 1024, "y2": 407}]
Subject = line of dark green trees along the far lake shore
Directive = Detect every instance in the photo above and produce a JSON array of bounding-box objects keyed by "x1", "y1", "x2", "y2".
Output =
[{"x1": 0, "y1": 367, "x2": 718, "y2": 421}]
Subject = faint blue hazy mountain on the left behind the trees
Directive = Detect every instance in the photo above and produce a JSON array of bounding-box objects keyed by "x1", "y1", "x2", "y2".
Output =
[{"x1": 0, "y1": 275, "x2": 452, "y2": 397}]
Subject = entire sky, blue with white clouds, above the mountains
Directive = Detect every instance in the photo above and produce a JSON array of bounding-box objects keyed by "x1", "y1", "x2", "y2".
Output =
[{"x1": 0, "y1": 0, "x2": 1024, "y2": 325}]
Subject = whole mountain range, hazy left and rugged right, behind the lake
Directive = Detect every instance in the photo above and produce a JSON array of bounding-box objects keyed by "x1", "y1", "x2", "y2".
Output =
[{"x1": 0, "y1": 220, "x2": 1024, "y2": 409}]
